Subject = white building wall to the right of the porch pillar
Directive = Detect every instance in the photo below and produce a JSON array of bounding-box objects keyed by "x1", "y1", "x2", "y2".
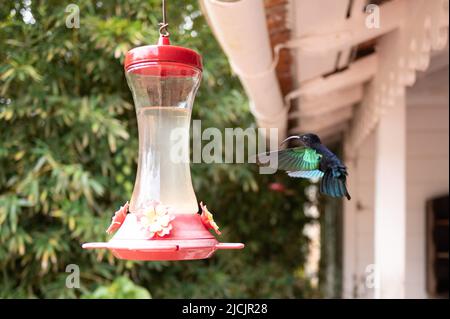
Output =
[{"x1": 406, "y1": 66, "x2": 449, "y2": 298}]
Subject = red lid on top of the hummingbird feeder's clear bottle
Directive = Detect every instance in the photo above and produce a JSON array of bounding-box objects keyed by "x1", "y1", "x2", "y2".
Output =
[{"x1": 125, "y1": 36, "x2": 202, "y2": 71}]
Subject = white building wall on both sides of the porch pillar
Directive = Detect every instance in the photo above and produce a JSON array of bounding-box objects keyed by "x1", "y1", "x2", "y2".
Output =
[{"x1": 343, "y1": 66, "x2": 449, "y2": 298}]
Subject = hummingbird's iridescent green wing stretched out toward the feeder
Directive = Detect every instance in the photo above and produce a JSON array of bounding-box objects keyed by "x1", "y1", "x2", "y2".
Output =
[{"x1": 256, "y1": 147, "x2": 323, "y2": 172}]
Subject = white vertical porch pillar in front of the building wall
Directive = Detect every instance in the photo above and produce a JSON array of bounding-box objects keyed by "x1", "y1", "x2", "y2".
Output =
[{"x1": 374, "y1": 98, "x2": 406, "y2": 298}]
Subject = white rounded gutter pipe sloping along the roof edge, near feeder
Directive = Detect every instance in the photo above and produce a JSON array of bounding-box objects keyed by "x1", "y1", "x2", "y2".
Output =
[{"x1": 200, "y1": 0, "x2": 288, "y2": 140}]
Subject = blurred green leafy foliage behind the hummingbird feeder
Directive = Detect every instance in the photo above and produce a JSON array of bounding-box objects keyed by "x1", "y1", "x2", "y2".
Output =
[{"x1": 0, "y1": 0, "x2": 315, "y2": 298}]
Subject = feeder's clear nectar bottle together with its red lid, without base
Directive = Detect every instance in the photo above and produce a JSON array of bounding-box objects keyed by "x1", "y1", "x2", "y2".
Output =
[{"x1": 125, "y1": 40, "x2": 202, "y2": 214}]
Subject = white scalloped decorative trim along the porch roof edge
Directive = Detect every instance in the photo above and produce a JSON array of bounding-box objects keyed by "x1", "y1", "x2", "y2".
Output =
[{"x1": 347, "y1": 0, "x2": 449, "y2": 152}]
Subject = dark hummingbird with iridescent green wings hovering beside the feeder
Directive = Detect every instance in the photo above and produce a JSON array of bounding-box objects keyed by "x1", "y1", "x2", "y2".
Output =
[{"x1": 257, "y1": 133, "x2": 351, "y2": 200}]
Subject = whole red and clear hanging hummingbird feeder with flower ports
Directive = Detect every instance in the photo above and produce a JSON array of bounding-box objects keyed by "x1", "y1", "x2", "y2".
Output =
[{"x1": 83, "y1": 1, "x2": 244, "y2": 260}]
